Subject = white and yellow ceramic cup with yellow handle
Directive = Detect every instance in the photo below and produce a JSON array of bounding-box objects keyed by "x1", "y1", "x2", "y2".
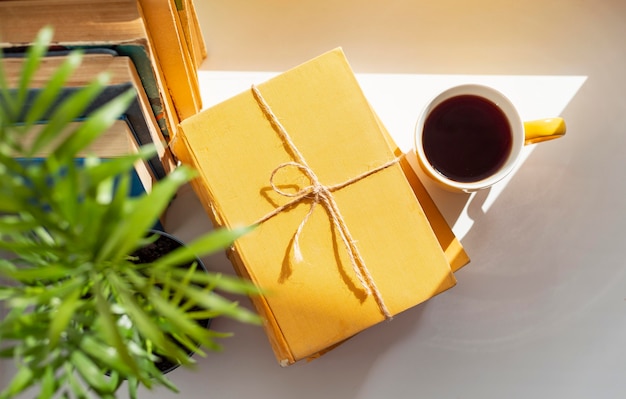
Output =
[{"x1": 415, "y1": 84, "x2": 565, "y2": 192}]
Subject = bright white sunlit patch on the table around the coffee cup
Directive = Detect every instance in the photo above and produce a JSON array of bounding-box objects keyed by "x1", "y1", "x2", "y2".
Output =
[{"x1": 199, "y1": 71, "x2": 586, "y2": 242}]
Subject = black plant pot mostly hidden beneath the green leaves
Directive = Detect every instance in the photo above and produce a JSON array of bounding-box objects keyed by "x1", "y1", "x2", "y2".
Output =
[{"x1": 132, "y1": 230, "x2": 212, "y2": 374}]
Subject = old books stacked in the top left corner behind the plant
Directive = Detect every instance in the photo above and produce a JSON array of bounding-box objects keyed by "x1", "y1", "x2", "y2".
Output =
[{"x1": 0, "y1": 0, "x2": 206, "y2": 194}]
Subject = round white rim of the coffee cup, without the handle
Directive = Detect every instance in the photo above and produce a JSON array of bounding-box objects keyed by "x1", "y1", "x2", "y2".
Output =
[{"x1": 413, "y1": 83, "x2": 524, "y2": 192}]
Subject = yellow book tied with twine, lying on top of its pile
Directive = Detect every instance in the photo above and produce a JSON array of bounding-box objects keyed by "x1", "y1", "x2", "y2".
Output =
[{"x1": 173, "y1": 49, "x2": 455, "y2": 366}]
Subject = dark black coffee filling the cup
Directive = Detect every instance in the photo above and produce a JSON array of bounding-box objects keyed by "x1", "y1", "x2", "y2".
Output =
[{"x1": 422, "y1": 95, "x2": 512, "y2": 183}]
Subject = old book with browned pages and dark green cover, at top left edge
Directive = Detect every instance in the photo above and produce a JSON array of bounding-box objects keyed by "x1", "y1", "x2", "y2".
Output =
[{"x1": 0, "y1": 0, "x2": 178, "y2": 140}]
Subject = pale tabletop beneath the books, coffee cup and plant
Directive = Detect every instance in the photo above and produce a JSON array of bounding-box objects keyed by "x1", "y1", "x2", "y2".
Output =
[{"x1": 0, "y1": 0, "x2": 626, "y2": 399}]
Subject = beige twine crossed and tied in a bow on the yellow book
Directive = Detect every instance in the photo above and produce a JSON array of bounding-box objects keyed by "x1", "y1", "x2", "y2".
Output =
[{"x1": 252, "y1": 85, "x2": 402, "y2": 319}]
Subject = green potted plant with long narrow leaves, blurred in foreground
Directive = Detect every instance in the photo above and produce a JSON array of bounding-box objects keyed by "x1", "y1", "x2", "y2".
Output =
[{"x1": 0, "y1": 29, "x2": 259, "y2": 399}]
